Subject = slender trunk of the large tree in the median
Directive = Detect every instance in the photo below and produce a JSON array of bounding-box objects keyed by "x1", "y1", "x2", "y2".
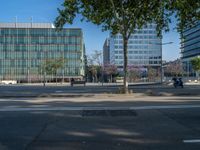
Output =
[{"x1": 123, "y1": 36, "x2": 128, "y2": 94}]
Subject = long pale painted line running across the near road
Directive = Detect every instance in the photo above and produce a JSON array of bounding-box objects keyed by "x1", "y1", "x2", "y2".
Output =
[{"x1": 0, "y1": 105, "x2": 200, "y2": 112}]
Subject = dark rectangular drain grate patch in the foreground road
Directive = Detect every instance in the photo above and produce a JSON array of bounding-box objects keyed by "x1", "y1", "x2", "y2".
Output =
[{"x1": 82, "y1": 110, "x2": 137, "y2": 117}]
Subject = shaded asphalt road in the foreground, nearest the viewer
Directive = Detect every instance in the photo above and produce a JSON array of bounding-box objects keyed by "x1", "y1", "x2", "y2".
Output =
[{"x1": 0, "y1": 97, "x2": 200, "y2": 150}]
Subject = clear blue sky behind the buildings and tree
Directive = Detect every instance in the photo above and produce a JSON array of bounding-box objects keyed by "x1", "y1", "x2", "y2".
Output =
[{"x1": 0, "y1": 0, "x2": 180, "y2": 61}]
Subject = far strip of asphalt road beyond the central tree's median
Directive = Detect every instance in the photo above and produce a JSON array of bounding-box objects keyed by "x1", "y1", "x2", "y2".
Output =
[{"x1": 0, "y1": 84, "x2": 200, "y2": 97}]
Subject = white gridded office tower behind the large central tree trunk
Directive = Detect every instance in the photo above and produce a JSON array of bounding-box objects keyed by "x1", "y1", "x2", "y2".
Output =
[{"x1": 104, "y1": 24, "x2": 162, "y2": 70}]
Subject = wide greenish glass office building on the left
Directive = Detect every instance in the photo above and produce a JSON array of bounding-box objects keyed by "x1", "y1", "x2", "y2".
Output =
[{"x1": 0, "y1": 23, "x2": 85, "y2": 82}]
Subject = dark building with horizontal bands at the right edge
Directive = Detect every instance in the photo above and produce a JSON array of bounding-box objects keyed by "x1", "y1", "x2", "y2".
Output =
[{"x1": 181, "y1": 21, "x2": 200, "y2": 76}]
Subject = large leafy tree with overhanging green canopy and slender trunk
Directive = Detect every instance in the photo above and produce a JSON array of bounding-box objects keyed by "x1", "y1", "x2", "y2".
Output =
[{"x1": 55, "y1": 0, "x2": 200, "y2": 93}]
